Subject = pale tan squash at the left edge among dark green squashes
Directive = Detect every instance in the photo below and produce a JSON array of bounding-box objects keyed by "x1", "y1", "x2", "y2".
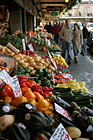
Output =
[{"x1": 0, "y1": 115, "x2": 15, "y2": 131}]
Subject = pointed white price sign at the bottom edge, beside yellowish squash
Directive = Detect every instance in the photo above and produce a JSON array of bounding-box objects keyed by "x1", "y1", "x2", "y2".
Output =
[{"x1": 50, "y1": 123, "x2": 72, "y2": 140}]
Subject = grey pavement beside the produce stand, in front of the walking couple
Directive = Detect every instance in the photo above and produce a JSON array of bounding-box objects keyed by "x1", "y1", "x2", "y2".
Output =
[{"x1": 69, "y1": 53, "x2": 93, "y2": 94}]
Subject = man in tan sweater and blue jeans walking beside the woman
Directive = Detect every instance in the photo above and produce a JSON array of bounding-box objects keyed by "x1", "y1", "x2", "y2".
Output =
[{"x1": 59, "y1": 20, "x2": 73, "y2": 64}]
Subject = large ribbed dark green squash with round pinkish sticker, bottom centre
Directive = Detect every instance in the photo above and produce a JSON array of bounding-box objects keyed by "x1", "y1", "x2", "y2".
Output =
[{"x1": 24, "y1": 110, "x2": 53, "y2": 132}]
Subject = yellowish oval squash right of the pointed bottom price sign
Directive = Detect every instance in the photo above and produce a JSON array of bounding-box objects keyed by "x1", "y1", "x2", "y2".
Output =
[{"x1": 66, "y1": 126, "x2": 81, "y2": 138}]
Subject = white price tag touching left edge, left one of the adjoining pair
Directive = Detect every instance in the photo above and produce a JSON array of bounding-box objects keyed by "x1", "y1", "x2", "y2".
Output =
[{"x1": 0, "y1": 70, "x2": 12, "y2": 85}]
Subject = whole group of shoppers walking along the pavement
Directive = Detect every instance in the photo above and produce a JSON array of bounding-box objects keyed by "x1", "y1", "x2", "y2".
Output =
[{"x1": 45, "y1": 20, "x2": 89, "y2": 64}]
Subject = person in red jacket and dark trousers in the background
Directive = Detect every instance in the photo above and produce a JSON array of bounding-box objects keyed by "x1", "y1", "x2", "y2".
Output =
[{"x1": 52, "y1": 23, "x2": 60, "y2": 44}]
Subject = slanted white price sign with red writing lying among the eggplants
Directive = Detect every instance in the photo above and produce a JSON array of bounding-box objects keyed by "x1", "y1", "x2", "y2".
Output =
[{"x1": 55, "y1": 103, "x2": 72, "y2": 121}]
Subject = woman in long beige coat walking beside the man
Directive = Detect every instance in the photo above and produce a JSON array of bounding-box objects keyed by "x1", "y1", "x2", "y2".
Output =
[{"x1": 72, "y1": 23, "x2": 83, "y2": 63}]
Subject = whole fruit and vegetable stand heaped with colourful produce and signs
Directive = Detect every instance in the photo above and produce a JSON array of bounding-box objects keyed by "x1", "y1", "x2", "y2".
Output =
[{"x1": 0, "y1": 33, "x2": 93, "y2": 140}]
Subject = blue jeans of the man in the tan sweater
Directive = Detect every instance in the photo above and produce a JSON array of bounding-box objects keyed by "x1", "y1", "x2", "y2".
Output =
[{"x1": 62, "y1": 42, "x2": 72, "y2": 62}]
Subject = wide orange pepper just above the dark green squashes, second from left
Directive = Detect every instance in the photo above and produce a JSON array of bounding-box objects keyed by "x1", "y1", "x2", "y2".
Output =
[{"x1": 12, "y1": 96, "x2": 27, "y2": 107}]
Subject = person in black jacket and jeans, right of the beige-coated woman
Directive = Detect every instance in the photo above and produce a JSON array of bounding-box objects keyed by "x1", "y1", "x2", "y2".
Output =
[{"x1": 81, "y1": 23, "x2": 89, "y2": 55}]
